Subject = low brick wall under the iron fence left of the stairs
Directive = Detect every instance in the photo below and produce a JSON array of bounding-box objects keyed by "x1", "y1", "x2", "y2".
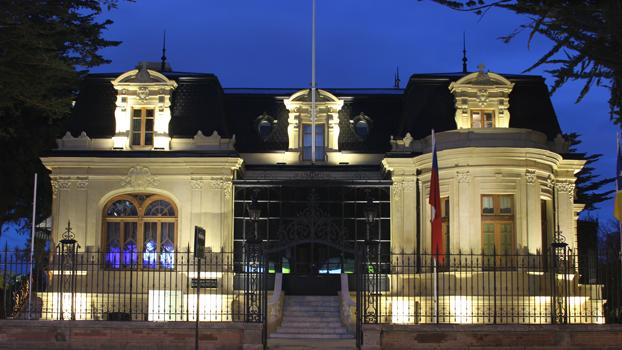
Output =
[{"x1": 0, "y1": 320, "x2": 262, "y2": 350}]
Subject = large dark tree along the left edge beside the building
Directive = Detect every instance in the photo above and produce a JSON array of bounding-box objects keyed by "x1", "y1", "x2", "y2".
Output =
[{"x1": 0, "y1": 0, "x2": 119, "y2": 234}]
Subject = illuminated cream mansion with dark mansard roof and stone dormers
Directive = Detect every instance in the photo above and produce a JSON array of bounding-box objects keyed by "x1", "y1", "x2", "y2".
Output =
[{"x1": 42, "y1": 64, "x2": 603, "y2": 323}]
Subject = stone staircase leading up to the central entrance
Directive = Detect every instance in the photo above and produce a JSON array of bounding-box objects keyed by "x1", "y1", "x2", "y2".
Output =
[{"x1": 270, "y1": 295, "x2": 353, "y2": 339}]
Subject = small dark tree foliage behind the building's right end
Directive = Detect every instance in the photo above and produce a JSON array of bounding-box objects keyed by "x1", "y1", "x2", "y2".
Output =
[{"x1": 564, "y1": 133, "x2": 615, "y2": 211}]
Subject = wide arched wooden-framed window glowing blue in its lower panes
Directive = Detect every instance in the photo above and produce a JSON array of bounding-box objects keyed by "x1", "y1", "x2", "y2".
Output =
[{"x1": 103, "y1": 194, "x2": 177, "y2": 269}]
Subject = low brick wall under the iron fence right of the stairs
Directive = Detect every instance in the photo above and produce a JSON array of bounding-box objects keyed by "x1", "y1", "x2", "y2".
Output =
[{"x1": 363, "y1": 325, "x2": 622, "y2": 350}]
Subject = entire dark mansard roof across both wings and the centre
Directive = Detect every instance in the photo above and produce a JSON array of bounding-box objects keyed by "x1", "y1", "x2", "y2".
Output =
[{"x1": 63, "y1": 72, "x2": 561, "y2": 153}]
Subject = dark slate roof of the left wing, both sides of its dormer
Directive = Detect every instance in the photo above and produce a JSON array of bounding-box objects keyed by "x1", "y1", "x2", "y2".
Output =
[{"x1": 65, "y1": 72, "x2": 232, "y2": 138}]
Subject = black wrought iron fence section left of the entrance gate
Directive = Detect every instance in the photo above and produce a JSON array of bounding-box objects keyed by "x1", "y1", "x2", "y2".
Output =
[{"x1": 0, "y1": 247, "x2": 263, "y2": 322}]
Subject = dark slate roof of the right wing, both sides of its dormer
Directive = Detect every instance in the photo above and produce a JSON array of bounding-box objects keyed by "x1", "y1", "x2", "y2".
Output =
[{"x1": 395, "y1": 73, "x2": 561, "y2": 139}]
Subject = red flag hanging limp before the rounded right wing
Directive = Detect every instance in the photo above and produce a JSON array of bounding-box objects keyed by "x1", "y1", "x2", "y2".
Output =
[{"x1": 428, "y1": 130, "x2": 445, "y2": 265}]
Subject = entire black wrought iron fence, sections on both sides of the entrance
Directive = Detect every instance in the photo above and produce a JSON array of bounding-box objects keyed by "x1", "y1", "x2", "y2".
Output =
[{"x1": 0, "y1": 244, "x2": 622, "y2": 324}]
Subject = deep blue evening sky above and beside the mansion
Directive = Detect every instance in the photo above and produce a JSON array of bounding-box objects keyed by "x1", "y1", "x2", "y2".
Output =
[{"x1": 6, "y1": 0, "x2": 616, "y2": 246}]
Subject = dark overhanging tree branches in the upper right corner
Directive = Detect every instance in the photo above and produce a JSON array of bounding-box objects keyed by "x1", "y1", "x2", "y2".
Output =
[{"x1": 434, "y1": 0, "x2": 622, "y2": 124}]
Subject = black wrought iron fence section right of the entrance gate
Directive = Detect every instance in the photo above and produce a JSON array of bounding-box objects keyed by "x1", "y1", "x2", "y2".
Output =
[{"x1": 361, "y1": 249, "x2": 622, "y2": 324}]
